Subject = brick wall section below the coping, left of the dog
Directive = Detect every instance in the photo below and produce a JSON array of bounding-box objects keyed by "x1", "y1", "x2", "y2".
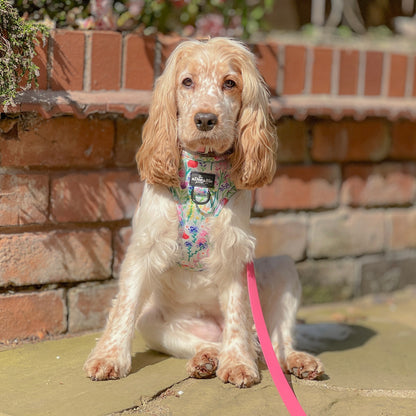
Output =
[{"x1": 0, "y1": 113, "x2": 144, "y2": 341}]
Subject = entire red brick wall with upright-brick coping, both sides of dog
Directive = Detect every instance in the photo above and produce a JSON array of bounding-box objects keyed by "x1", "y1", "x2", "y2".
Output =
[{"x1": 0, "y1": 31, "x2": 416, "y2": 342}]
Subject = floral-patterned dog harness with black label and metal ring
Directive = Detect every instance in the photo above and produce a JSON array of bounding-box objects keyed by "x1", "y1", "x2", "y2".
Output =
[{"x1": 170, "y1": 151, "x2": 237, "y2": 271}]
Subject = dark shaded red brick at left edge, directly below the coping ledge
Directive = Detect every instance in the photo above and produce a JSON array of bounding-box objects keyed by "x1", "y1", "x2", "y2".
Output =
[{"x1": 0, "y1": 117, "x2": 114, "y2": 167}]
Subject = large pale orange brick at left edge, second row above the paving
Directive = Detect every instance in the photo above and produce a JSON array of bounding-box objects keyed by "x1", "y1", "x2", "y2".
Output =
[{"x1": 0, "y1": 228, "x2": 112, "y2": 286}]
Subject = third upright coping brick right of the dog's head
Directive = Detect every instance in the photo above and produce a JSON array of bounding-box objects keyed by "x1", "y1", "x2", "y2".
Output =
[{"x1": 311, "y1": 46, "x2": 333, "y2": 94}]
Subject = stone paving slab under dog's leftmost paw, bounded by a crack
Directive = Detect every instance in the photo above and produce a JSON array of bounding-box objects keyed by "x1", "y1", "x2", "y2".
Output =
[{"x1": 0, "y1": 335, "x2": 186, "y2": 416}]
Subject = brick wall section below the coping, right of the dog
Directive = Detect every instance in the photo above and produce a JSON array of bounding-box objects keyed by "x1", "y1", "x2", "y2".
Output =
[{"x1": 252, "y1": 118, "x2": 416, "y2": 301}]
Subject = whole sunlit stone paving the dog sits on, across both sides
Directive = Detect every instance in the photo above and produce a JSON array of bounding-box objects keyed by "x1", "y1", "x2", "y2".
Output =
[{"x1": 0, "y1": 289, "x2": 416, "y2": 416}]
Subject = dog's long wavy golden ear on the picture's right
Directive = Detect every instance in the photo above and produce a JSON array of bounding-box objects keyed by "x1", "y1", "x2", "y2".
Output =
[{"x1": 231, "y1": 44, "x2": 277, "y2": 189}]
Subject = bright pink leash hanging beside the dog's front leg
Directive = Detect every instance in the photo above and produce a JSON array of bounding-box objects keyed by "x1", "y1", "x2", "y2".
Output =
[{"x1": 247, "y1": 263, "x2": 306, "y2": 416}]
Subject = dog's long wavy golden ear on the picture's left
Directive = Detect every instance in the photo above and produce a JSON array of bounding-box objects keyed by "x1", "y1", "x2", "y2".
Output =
[{"x1": 136, "y1": 44, "x2": 180, "y2": 186}]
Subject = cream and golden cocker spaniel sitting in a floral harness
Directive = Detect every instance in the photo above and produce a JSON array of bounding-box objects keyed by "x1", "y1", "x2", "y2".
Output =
[{"x1": 84, "y1": 38, "x2": 323, "y2": 387}]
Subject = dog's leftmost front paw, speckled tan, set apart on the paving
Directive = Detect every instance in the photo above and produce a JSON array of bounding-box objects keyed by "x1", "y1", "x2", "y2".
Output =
[{"x1": 84, "y1": 355, "x2": 131, "y2": 381}]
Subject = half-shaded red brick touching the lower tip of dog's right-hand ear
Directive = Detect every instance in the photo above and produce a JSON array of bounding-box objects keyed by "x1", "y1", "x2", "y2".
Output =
[{"x1": 256, "y1": 165, "x2": 340, "y2": 210}]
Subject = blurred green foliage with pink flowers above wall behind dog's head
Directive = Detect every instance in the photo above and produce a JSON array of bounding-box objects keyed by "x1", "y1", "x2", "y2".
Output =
[{"x1": 13, "y1": 0, "x2": 274, "y2": 38}]
